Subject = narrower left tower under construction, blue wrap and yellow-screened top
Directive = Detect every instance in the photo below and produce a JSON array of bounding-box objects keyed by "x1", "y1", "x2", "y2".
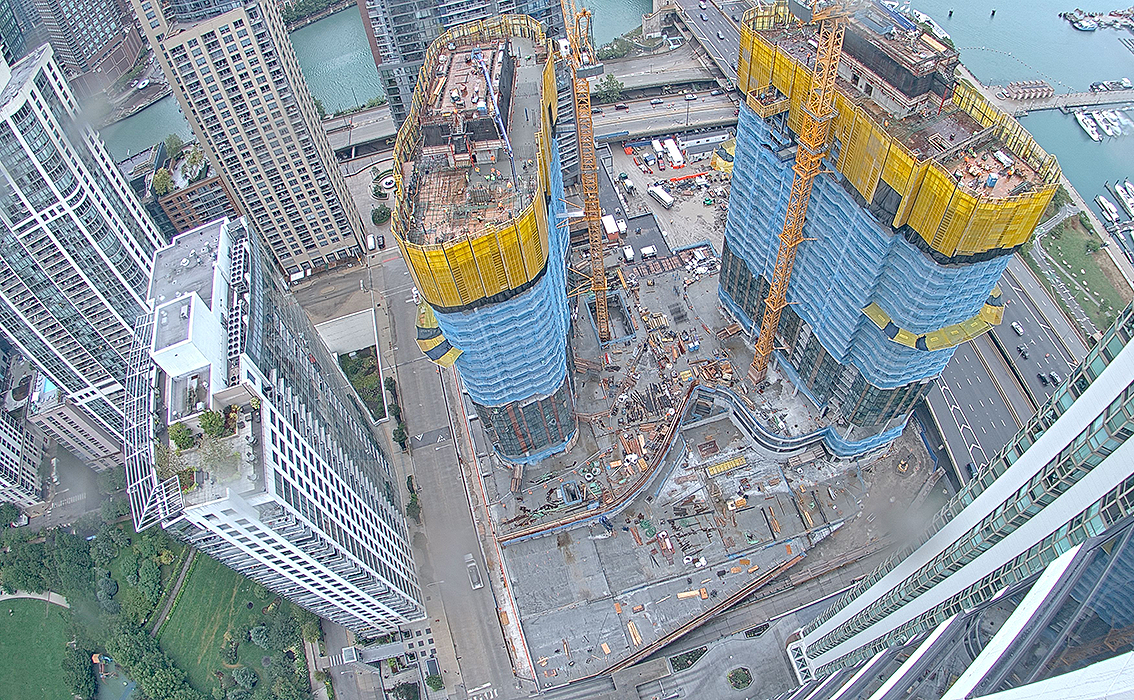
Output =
[{"x1": 393, "y1": 15, "x2": 577, "y2": 463}]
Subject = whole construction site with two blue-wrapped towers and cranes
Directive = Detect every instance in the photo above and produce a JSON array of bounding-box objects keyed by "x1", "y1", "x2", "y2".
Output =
[{"x1": 395, "y1": 1, "x2": 1059, "y2": 689}]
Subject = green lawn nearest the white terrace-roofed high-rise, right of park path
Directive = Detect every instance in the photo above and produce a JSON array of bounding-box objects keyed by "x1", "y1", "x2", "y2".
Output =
[{"x1": 158, "y1": 554, "x2": 271, "y2": 693}]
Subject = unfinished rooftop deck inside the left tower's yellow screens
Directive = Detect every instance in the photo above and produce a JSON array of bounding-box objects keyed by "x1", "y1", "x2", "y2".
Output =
[{"x1": 403, "y1": 36, "x2": 545, "y2": 244}]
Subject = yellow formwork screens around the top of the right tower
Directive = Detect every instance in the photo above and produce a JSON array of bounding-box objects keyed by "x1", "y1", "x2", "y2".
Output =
[{"x1": 737, "y1": 0, "x2": 1060, "y2": 258}]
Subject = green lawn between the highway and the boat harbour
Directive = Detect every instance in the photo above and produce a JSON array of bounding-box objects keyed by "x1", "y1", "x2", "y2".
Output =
[{"x1": 1040, "y1": 217, "x2": 1131, "y2": 329}]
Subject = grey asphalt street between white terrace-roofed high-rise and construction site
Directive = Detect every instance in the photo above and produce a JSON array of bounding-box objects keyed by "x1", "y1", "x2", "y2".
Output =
[{"x1": 373, "y1": 250, "x2": 517, "y2": 698}]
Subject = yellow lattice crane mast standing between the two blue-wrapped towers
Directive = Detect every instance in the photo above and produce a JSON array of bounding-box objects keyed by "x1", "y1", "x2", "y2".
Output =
[{"x1": 561, "y1": 0, "x2": 610, "y2": 343}]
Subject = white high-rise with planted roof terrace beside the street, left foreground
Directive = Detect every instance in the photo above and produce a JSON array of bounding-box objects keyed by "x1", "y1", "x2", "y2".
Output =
[{"x1": 126, "y1": 219, "x2": 424, "y2": 636}]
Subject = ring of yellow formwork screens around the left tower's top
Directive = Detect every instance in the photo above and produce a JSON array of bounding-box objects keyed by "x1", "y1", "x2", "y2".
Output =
[{"x1": 392, "y1": 15, "x2": 557, "y2": 309}]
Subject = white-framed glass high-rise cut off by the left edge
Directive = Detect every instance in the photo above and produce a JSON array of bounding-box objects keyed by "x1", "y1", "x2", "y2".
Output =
[{"x1": 0, "y1": 44, "x2": 159, "y2": 458}]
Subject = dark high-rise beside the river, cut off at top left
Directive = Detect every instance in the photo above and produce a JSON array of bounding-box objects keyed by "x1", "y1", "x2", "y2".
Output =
[{"x1": 32, "y1": 0, "x2": 144, "y2": 98}]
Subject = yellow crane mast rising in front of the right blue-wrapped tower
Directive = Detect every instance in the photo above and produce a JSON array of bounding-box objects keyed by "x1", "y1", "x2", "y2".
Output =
[{"x1": 748, "y1": 0, "x2": 848, "y2": 383}]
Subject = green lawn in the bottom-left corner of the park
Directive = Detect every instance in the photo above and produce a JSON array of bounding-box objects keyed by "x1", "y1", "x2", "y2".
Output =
[{"x1": 0, "y1": 600, "x2": 71, "y2": 700}]
